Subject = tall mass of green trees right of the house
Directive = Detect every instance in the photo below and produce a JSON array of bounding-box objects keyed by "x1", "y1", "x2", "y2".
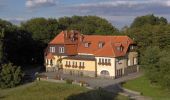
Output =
[{"x1": 122, "y1": 14, "x2": 170, "y2": 88}]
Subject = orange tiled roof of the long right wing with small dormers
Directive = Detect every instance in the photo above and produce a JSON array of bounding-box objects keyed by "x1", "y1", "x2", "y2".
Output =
[{"x1": 78, "y1": 35, "x2": 133, "y2": 57}]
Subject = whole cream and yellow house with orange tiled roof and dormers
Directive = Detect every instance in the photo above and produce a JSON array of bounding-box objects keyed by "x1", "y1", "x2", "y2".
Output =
[{"x1": 44, "y1": 30, "x2": 138, "y2": 78}]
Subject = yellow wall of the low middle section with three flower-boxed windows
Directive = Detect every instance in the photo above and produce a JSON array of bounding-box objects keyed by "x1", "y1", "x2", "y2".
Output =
[{"x1": 62, "y1": 59, "x2": 96, "y2": 77}]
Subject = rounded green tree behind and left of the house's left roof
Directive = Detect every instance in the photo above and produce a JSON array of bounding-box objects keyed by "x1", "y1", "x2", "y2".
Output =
[{"x1": 21, "y1": 18, "x2": 59, "y2": 43}]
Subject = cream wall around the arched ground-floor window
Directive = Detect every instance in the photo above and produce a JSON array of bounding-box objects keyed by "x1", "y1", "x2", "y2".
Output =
[{"x1": 95, "y1": 57, "x2": 115, "y2": 77}]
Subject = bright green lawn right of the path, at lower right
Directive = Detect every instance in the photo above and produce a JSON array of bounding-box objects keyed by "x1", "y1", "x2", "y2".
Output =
[{"x1": 123, "y1": 76, "x2": 170, "y2": 100}]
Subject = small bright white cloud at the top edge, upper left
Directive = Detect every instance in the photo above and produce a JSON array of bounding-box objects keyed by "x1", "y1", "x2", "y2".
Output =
[{"x1": 25, "y1": 0, "x2": 56, "y2": 8}]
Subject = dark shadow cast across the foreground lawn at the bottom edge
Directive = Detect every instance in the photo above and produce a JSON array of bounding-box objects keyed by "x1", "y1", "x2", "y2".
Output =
[{"x1": 65, "y1": 86, "x2": 125, "y2": 100}]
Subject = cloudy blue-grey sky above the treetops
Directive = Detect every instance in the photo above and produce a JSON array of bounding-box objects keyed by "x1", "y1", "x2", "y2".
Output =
[{"x1": 0, "y1": 0, "x2": 170, "y2": 28}]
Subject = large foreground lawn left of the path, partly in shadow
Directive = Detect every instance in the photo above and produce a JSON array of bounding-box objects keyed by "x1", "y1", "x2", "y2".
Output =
[{"x1": 0, "y1": 81, "x2": 128, "y2": 100}]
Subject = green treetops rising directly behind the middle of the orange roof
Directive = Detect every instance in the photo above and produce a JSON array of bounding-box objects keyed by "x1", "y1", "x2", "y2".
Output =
[{"x1": 59, "y1": 16, "x2": 118, "y2": 35}]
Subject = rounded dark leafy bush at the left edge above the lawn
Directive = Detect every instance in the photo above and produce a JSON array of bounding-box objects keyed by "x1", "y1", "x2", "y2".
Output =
[{"x1": 0, "y1": 63, "x2": 23, "y2": 88}]
